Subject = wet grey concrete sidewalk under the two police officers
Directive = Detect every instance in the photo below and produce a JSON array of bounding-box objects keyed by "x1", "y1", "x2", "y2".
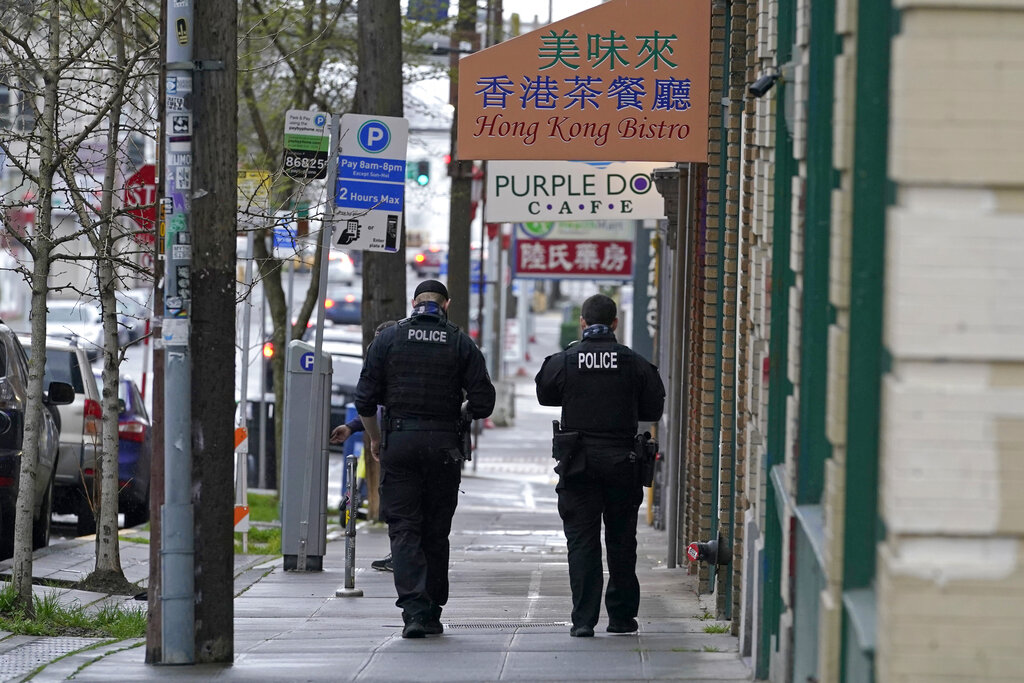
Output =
[{"x1": 0, "y1": 316, "x2": 751, "y2": 683}]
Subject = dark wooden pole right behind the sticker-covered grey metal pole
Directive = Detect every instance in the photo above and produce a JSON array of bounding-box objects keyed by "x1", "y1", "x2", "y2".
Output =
[{"x1": 190, "y1": 0, "x2": 237, "y2": 664}]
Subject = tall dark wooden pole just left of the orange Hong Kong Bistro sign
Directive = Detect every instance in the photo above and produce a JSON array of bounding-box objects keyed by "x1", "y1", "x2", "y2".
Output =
[{"x1": 447, "y1": 0, "x2": 483, "y2": 331}]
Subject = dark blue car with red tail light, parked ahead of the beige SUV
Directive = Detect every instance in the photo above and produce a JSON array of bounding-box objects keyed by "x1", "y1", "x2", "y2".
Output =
[{"x1": 92, "y1": 370, "x2": 153, "y2": 526}]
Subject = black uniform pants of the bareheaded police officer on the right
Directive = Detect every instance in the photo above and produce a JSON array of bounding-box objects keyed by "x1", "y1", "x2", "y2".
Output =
[{"x1": 556, "y1": 446, "x2": 643, "y2": 628}]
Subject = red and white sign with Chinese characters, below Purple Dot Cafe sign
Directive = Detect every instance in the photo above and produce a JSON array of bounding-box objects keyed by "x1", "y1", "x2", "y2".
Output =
[{"x1": 513, "y1": 221, "x2": 634, "y2": 280}]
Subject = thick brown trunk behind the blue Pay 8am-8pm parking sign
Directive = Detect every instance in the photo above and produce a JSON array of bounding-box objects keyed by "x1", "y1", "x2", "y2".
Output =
[{"x1": 352, "y1": 0, "x2": 409, "y2": 520}]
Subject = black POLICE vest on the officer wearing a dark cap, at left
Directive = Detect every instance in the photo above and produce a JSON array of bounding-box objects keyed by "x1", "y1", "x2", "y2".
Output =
[{"x1": 385, "y1": 315, "x2": 462, "y2": 422}]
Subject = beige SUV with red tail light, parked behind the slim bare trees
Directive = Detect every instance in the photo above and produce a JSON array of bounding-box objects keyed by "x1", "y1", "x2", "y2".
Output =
[{"x1": 20, "y1": 336, "x2": 103, "y2": 536}]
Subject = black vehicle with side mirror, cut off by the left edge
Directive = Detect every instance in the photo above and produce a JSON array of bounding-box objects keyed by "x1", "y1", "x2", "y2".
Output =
[{"x1": 0, "y1": 323, "x2": 75, "y2": 559}]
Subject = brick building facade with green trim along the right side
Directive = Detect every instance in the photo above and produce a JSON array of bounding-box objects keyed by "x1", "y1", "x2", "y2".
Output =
[{"x1": 662, "y1": 0, "x2": 1024, "y2": 682}]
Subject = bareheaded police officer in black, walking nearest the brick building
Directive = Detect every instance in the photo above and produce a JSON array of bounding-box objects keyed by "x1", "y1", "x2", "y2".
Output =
[{"x1": 536, "y1": 294, "x2": 665, "y2": 638}]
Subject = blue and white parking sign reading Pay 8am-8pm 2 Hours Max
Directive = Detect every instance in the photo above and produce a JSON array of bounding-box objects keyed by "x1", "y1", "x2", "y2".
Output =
[{"x1": 332, "y1": 114, "x2": 409, "y2": 252}]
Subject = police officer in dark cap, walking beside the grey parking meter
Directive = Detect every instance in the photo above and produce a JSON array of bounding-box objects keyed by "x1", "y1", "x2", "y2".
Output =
[{"x1": 355, "y1": 280, "x2": 495, "y2": 638}]
